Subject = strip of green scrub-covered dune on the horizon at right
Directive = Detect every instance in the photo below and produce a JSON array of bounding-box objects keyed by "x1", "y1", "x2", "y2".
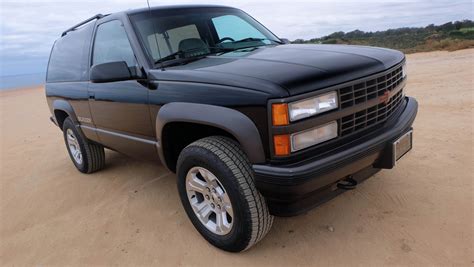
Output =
[{"x1": 293, "y1": 20, "x2": 474, "y2": 53}]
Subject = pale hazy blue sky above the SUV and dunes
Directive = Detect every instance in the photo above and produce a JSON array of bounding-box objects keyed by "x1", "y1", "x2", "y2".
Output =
[{"x1": 0, "y1": 0, "x2": 473, "y2": 75}]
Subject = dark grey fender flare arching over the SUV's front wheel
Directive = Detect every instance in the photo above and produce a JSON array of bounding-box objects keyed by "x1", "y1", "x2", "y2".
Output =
[{"x1": 156, "y1": 102, "x2": 265, "y2": 164}]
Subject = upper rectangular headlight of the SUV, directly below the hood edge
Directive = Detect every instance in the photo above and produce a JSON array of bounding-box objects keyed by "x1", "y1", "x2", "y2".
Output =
[{"x1": 288, "y1": 91, "x2": 337, "y2": 121}]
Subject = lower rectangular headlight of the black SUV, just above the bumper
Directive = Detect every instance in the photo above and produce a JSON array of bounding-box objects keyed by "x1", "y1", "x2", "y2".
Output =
[{"x1": 291, "y1": 121, "x2": 337, "y2": 152}]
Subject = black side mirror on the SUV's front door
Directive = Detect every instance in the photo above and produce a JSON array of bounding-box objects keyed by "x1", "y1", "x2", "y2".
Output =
[{"x1": 90, "y1": 61, "x2": 133, "y2": 83}]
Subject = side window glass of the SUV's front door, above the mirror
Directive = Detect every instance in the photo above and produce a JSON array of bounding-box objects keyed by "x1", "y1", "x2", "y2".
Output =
[{"x1": 92, "y1": 20, "x2": 136, "y2": 67}]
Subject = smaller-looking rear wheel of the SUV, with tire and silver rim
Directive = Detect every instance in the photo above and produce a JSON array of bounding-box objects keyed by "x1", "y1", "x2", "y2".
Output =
[{"x1": 63, "y1": 118, "x2": 105, "y2": 173}]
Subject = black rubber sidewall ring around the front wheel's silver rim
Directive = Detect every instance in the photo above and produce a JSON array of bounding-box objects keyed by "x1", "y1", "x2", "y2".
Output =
[{"x1": 177, "y1": 146, "x2": 252, "y2": 251}]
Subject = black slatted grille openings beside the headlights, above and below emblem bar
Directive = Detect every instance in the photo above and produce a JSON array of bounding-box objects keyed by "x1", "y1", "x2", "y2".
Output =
[{"x1": 338, "y1": 66, "x2": 403, "y2": 137}]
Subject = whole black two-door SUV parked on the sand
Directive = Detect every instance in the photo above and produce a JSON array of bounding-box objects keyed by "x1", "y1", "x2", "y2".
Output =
[{"x1": 46, "y1": 6, "x2": 418, "y2": 251}]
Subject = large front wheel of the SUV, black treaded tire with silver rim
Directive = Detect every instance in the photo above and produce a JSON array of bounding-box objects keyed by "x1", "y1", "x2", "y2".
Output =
[{"x1": 177, "y1": 136, "x2": 273, "y2": 252}]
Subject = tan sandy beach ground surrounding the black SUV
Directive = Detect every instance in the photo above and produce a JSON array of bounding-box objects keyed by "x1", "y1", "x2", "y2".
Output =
[{"x1": 0, "y1": 50, "x2": 474, "y2": 266}]
